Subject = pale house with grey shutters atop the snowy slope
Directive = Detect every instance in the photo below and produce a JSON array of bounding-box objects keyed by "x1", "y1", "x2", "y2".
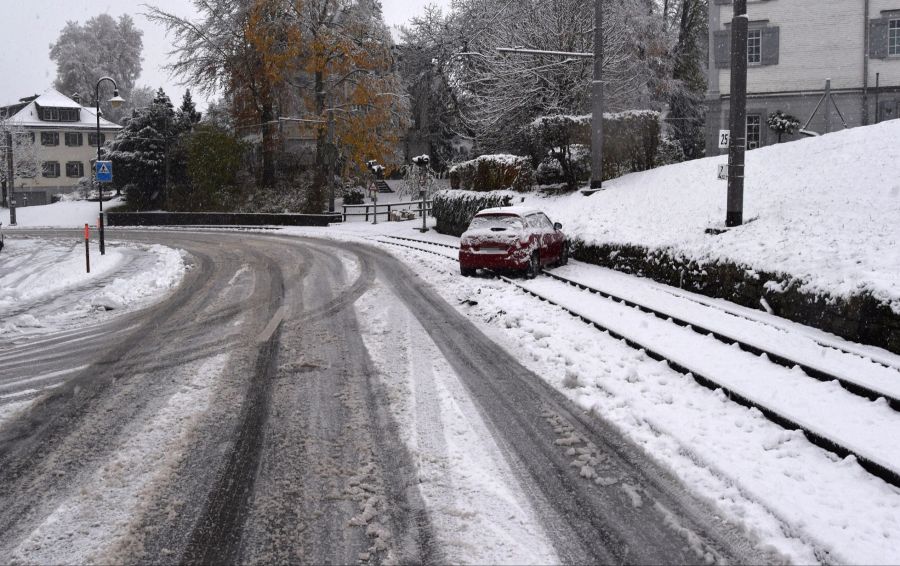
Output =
[{"x1": 706, "y1": 0, "x2": 900, "y2": 155}]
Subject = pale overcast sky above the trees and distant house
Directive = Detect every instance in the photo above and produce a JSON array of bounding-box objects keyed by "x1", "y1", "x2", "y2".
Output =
[{"x1": 0, "y1": 0, "x2": 450, "y2": 111}]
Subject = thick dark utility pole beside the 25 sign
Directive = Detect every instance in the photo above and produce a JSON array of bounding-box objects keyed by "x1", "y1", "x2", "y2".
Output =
[{"x1": 725, "y1": 0, "x2": 749, "y2": 228}]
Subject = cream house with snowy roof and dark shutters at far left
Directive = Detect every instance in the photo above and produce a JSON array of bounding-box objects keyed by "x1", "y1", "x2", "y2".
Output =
[{"x1": 0, "y1": 89, "x2": 121, "y2": 206}]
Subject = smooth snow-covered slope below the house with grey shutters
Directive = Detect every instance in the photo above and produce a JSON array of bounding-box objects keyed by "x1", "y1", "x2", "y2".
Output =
[{"x1": 525, "y1": 120, "x2": 900, "y2": 313}]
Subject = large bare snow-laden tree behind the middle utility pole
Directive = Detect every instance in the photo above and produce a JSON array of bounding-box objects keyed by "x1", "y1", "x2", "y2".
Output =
[{"x1": 438, "y1": 0, "x2": 659, "y2": 155}]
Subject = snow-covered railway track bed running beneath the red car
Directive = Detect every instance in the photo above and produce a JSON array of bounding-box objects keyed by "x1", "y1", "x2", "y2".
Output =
[{"x1": 379, "y1": 236, "x2": 900, "y2": 492}]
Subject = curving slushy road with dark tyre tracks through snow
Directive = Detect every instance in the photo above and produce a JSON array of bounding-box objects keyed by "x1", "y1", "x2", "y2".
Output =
[{"x1": 0, "y1": 231, "x2": 764, "y2": 563}]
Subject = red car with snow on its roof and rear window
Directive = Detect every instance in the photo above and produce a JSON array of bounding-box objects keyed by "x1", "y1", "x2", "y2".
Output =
[{"x1": 459, "y1": 206, "x2": 569, "y2": 277}]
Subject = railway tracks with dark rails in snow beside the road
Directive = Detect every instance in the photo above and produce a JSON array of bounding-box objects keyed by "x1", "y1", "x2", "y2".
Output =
[{"x1": 377, "y1": 236, "x2": 900, "y2": 487}]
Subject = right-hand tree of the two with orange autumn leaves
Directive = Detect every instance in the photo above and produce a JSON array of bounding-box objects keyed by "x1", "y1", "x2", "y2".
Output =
[{"x1": 268, "y1": 0, "x2": 409, "y2": 210}]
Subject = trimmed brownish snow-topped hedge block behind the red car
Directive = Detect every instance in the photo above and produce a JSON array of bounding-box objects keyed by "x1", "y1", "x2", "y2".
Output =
[{"x1": 450, "y1": 154, "x2": 534, "y2": 192}]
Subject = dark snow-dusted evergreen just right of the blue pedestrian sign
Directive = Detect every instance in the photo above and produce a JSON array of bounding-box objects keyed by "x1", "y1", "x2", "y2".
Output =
[{"x1": 106, "y1": 89, "x2": 184, "y2": 210}]
